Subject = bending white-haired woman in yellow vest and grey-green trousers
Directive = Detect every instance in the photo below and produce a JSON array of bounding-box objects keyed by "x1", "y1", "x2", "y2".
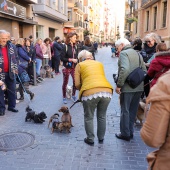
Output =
[{"x1": 75, "y1": 50, "x2": 113, "y2": 145}]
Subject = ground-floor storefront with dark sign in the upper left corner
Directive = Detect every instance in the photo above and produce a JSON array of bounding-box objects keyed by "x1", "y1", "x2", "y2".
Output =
[{"x1": 0, "y1": 0, "x2": 36, "y2": 39}]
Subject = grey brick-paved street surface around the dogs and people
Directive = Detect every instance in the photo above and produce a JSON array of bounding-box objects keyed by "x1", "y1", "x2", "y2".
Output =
[{"x1": 0, "y1": 47, "x2": 153, "y2": 170}]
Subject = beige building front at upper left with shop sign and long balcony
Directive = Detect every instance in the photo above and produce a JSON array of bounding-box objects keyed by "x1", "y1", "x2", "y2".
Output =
[{"x1": 0, "y1": 0, "x2": 67, "y2": 40}]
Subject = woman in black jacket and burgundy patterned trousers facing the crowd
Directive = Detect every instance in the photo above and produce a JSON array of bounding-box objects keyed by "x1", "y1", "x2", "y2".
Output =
[{"x1": 61, "y1": 32, "x2": 78, "y2": 104}]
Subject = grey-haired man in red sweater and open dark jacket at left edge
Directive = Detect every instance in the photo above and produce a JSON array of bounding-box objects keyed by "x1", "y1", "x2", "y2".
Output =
[{"x1": 0, "y1": 30, "x2": 18, "y2": 116}]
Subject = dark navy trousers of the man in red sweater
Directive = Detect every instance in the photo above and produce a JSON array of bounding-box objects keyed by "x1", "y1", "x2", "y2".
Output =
[{"x1": 0, "y1": 73, "x2": 16, "y2": 111}]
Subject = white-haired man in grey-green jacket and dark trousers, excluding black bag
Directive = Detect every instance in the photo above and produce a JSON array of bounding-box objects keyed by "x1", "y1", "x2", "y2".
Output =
[{"x1": 115, "y1": 38, "x2": 146, "y2": 141}]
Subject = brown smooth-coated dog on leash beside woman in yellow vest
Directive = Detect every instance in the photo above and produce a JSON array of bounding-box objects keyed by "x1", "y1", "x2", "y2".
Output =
[{"x1": 58, "y1": 106, "x2": 73, "y2": 133}]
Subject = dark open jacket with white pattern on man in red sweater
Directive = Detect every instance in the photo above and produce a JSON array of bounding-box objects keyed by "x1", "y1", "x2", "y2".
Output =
[{"x1": 0, "y1": 41, "x2": 18, "y2": 81}]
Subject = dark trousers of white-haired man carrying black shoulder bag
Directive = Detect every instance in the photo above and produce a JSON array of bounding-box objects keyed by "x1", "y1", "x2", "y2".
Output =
[{"x1": 120, "y1": 92, "x2": 142, "y2": 136}]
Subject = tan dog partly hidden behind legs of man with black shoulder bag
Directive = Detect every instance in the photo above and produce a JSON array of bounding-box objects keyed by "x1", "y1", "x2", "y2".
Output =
[{"x1": 135, "y1": 101, "x2": 146, "y2": 126}]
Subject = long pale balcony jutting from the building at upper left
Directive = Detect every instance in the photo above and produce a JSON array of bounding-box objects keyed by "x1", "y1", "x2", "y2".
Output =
[{"x1": 33, "y1": 4, "x2": 67, "y2": 22}]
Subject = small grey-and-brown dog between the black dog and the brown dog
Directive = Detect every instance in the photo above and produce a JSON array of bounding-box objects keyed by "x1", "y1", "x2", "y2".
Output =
[{"x1": 48, "y1": 113, "x2": 61, "y2": 133}]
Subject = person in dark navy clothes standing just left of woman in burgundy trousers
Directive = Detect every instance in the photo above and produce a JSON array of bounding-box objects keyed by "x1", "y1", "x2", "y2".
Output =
[{"x1": 53, "y1": 37, "x2": 63, "y2": 75}]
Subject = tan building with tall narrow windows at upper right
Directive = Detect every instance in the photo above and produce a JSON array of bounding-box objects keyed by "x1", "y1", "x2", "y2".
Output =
[{"x1": 133, "y1": 0, "x2": 170, "y2": 47}]
